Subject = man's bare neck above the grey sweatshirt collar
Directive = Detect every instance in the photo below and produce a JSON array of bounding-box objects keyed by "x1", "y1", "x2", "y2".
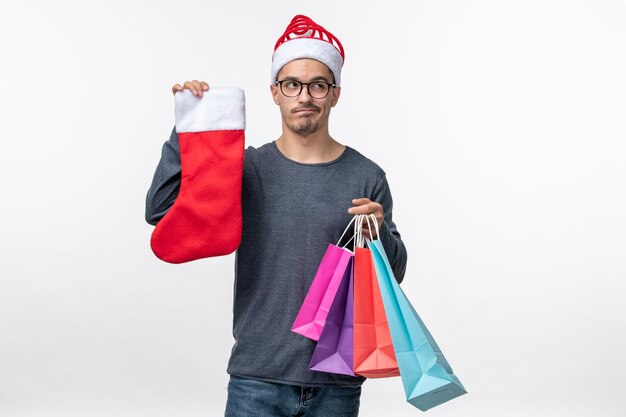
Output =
[{"x1": 276, "y1": 129, "x2": 345, "y2": 164}]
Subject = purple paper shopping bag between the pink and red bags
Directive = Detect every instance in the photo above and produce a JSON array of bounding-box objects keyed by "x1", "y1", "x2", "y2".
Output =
[{"x1": 309, "y1": 255, "x2": 354, "y2": 376}]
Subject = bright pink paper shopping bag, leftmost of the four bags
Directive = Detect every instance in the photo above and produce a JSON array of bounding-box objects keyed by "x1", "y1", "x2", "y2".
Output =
[{"x1": 291, "y1": 218, "x2": 354, "y2": 341}]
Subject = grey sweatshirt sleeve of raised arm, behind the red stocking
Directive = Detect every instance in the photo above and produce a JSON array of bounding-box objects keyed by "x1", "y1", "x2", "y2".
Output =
[{"x1": 145, "y1": 128, "x2": 181, "y2": 226}]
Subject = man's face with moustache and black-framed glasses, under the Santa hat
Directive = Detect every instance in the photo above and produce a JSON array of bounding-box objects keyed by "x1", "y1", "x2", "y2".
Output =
[{"x1": 270, "y1": 59, "x2": 341, "y2": 136}]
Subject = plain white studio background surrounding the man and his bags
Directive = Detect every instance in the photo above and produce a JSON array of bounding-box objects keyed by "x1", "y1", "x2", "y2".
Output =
[{"x1": 0, "y1": 0, "x2": 626, "y2": 417}]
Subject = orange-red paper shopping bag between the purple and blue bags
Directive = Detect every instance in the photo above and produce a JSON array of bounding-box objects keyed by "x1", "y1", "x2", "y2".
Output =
[{"x1": 354, "y1": 216, "x2": 400, "y2": 378}]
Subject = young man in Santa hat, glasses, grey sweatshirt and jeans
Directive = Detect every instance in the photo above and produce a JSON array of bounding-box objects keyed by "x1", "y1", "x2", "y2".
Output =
[{"x1": 146, "y1": 16, "x2": 407, "y2": 417}]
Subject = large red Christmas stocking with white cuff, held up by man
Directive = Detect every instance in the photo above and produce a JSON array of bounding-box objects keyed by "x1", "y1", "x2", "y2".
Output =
[{"x1": 150, "y1": 87, "x2": 245, "y2": 264}]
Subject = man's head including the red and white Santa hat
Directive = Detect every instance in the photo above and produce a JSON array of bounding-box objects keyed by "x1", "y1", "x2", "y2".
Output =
[{"x1": 271, "y1": 15, "x2": 344, "y2": 136}]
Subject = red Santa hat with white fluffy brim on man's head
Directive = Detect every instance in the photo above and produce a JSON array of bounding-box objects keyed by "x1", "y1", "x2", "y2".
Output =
[{"x1": 271, "y1": 14, "x2": 345, "y2": 87}]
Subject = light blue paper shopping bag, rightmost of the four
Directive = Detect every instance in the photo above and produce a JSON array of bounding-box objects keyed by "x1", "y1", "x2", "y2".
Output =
[{"x1": 369, "y1": 214, "x2": 467, "y2": 411}]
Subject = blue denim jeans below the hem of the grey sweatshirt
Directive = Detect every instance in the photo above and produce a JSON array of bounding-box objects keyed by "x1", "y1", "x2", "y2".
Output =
[{"x1": 224, "y1": 376, "x2": 361, "y2": 417}]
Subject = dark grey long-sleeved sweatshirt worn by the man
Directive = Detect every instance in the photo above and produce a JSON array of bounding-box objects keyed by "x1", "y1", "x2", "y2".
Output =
[{"x1": 146, "y1": 129, "x2": 407, "y2": 386}]
